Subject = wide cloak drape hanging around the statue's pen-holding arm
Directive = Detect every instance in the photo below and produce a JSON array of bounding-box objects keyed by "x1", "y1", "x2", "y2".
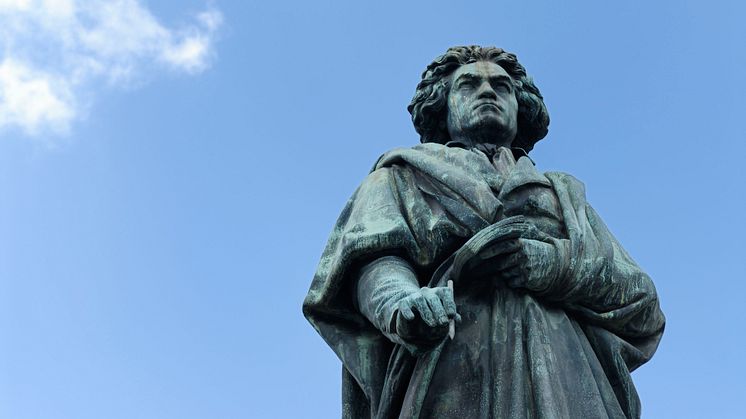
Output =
[{"x1": 303, "y1": 165, "x2": 457, "y2": 405}]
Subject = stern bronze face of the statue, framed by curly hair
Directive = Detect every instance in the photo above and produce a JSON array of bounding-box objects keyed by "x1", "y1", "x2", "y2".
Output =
[{"x1": 447, "y1": 61, "x2": 518, "y2": 147}]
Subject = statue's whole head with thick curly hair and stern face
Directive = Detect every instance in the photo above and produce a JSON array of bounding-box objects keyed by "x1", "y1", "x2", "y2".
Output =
[{"x1": 407, "y1": 46, "x2": 549, "y2": 152}]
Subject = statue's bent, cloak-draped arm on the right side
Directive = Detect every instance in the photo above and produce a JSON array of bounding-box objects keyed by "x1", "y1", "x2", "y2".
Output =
[{"x1": 513, "y1": 174, "x2": 665, "y2": 369}]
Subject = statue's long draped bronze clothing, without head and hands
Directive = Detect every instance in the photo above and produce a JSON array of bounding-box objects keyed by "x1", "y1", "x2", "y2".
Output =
[{"x1": 303, "y1": 143, "x2": 665, "y2": 418}]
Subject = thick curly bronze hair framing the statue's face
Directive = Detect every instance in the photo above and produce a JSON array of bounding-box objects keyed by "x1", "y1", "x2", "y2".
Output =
[{"x1": 407, "y1": 45, "x2": 549, "y2": 152}]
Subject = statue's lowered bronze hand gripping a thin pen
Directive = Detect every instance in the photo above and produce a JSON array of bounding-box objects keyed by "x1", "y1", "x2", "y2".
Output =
[{"x1": 396, "y1": 287, "x2": 461, "y2": 344}]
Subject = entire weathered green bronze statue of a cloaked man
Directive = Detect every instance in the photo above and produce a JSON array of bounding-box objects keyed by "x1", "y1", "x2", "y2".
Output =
[{"x1": 303, "y1": 46, "x2": 665, "y2": 419}]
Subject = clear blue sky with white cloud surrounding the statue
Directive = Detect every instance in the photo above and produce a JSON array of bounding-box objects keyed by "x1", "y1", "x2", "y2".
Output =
[{"x1": 0, "y1": 0, "x2": 746, "y2": 419}]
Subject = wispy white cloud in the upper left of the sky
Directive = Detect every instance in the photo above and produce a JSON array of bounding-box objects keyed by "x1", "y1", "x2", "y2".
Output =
[{"x1": 0, "y1": 0, "x2": 222, "y2": 135}]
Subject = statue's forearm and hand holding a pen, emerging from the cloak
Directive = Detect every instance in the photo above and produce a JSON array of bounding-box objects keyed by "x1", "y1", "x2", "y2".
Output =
[{"x1": 355, "y1": 256, "x2": 459, "y2": 352}]
